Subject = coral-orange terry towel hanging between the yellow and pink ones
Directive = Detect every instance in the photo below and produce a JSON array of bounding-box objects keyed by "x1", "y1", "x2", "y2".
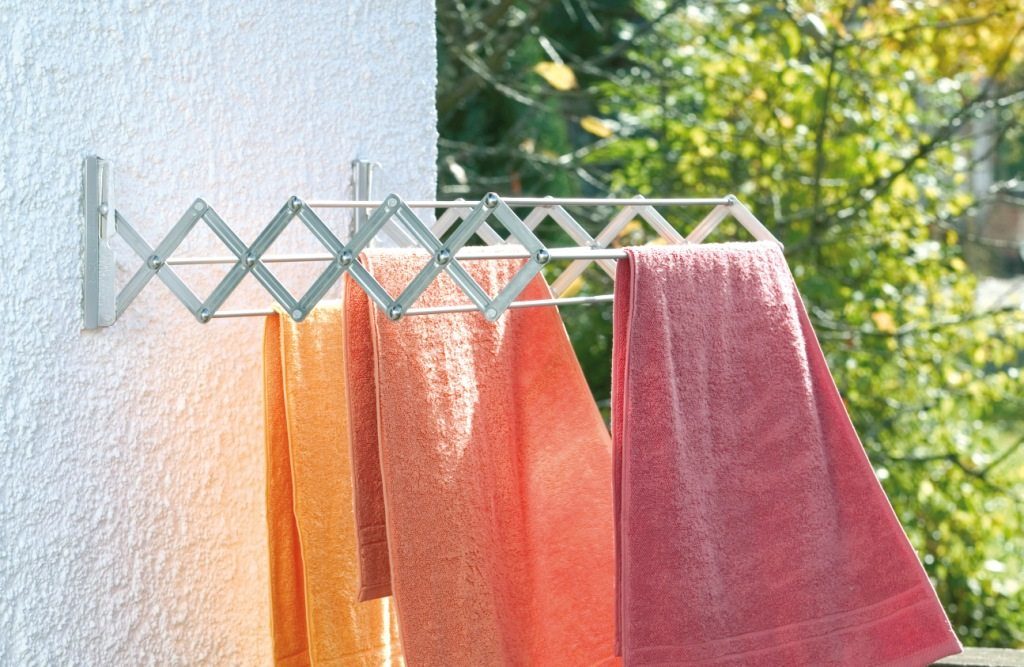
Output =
[{"x1": 345, "y1": 250, "x2": 615, "y2": 667}]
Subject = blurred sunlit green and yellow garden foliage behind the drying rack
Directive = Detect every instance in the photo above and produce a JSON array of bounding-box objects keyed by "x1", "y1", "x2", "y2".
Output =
[{"x1": 437, "y1": 0, "x2": 1024, "y2": 648}]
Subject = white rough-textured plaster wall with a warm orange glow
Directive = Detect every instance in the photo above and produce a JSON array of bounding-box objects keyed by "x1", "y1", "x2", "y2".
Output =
[{"x1": 0, "y1": 0, "x2": 435, "y2": 665}]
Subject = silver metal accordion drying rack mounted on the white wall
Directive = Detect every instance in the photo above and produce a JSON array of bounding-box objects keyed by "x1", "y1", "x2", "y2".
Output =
[{"x1": 83, "y1": 157, "x2": 778, "y2": 329}]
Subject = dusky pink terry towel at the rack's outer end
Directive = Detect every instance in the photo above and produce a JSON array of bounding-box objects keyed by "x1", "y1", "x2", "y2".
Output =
[{"x1": 612, "y1": 242, "x2": 961, "y2": 665}]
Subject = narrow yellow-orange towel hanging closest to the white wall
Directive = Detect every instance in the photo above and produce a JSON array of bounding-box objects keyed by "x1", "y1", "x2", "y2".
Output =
[{"x1": 263, "y1": 303, "x2": 402, "y2": 667}]
